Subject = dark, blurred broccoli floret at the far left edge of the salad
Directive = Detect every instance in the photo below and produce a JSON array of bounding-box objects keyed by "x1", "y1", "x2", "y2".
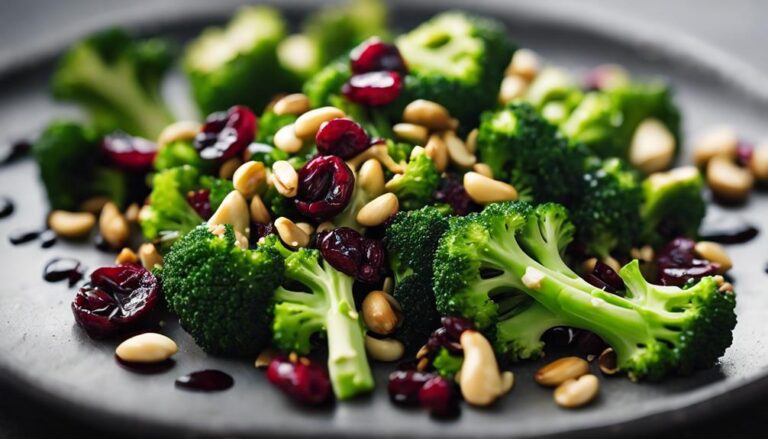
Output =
[{"x1": 32, "y1": 121, "x2": 128, "y2": 210}]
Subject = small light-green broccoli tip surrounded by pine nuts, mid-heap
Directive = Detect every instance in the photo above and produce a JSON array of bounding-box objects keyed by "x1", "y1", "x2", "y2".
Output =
[{"x1": 386, "y1": 154, "x2": 440, "y2": 210}]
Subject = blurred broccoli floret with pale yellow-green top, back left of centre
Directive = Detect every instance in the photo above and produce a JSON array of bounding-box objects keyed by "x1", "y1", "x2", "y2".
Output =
[{"x1": 184, "y1": 6, "x2": 299, "y2": 114}]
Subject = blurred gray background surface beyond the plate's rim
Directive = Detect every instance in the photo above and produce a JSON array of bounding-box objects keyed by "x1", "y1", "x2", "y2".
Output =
[{"x1": 0, "y1": 0, "x2": 768, "y2": 438}]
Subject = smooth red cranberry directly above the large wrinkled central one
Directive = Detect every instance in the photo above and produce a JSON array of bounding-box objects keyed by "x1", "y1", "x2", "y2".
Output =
[{"x1": 315, "y1": 118, "x2": 370, "y2": 160}]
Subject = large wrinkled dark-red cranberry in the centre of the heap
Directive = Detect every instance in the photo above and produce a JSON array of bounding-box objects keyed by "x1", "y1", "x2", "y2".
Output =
[{"x1": 295, "y1": 155, "x2": 355, "y2": 221}]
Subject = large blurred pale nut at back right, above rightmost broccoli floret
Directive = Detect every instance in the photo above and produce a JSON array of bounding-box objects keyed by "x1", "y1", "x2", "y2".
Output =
[{"x1": 629, "y1": 119, "x2": 676, "y2": 175}]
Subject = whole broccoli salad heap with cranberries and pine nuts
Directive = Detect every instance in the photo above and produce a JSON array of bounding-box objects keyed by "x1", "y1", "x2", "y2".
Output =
[{"x1": 25, "y1": 0, "x2": 768, "y2": 416}]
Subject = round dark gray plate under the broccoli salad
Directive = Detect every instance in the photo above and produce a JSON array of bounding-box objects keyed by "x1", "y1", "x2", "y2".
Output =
[{"x1": 0, "y1": 1, "x2": 768, "y2": 437}]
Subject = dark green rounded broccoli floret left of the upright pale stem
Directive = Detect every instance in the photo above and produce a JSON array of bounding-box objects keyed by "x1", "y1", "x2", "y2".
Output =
[{"x1": 160, "y1": 225, "x2": 284, "y2": 356}]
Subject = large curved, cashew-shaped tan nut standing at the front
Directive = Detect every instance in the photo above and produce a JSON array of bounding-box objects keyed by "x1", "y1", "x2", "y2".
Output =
[{"x1": 459, "y1": 330, "x2": 513, "y2": 406}]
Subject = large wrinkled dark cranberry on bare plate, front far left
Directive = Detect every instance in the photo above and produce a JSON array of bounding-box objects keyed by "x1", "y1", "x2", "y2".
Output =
[{"x1": 72, "y1": 264, "x2": 160, "y2": 338}]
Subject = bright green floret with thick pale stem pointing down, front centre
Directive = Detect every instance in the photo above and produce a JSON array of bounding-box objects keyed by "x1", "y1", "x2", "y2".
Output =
[{"x1": 266, "y1": 239, "x2": 374, "y2": 399}]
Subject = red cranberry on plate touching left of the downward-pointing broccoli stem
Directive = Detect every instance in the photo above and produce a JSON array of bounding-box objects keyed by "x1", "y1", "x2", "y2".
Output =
[{"x1": 267, "y1": 355, "x2": 331, "y2": 405}]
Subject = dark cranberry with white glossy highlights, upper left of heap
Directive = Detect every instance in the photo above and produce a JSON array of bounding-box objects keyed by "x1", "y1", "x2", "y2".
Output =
[{"x1": 195, "y1": 105, "x2": 258, "y2": 162}]
